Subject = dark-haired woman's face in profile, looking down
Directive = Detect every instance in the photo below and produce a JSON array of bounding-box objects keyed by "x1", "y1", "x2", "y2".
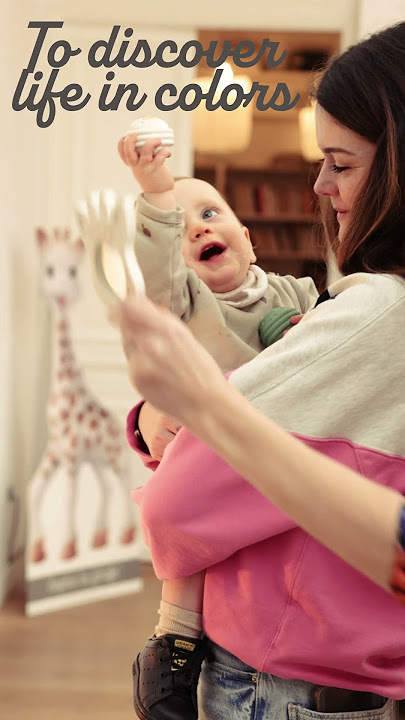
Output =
[{"x1": 314, "y1": 105, "x2": 376, "y2": 240}]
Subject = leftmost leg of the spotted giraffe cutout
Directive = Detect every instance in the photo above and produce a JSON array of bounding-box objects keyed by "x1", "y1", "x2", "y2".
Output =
[{"x1": 27, "y1": 453, "x2": 59, "y2": 563}]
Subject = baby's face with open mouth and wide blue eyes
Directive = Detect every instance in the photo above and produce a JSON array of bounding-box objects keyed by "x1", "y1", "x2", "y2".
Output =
[{"x1": 174, "y1": 178, "x2": 256, "y2": 293}]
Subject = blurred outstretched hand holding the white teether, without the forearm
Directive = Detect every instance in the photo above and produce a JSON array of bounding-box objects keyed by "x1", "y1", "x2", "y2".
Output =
[{"x1": 120, "y1": 295, "x2": 226, "y2": 428}]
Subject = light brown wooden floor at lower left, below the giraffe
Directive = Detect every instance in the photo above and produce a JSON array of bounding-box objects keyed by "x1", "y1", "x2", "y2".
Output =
[{"x1": 0, "y1": 565, "x2": 160, "y2": 720}]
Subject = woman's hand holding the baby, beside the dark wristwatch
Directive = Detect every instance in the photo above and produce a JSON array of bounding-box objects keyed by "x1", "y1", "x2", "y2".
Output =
[{"x1": 138, "y1": 402, "x2": 181, "y2": 462}]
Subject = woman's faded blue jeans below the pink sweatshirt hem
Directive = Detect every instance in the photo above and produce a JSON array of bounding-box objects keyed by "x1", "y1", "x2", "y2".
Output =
[{"x1": 198, "y1": 642, "x2": 396, "y2": 720}]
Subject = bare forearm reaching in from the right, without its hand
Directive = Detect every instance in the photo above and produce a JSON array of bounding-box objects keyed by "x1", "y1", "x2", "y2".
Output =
[{"x1": 190, "y1": 382, "x2": 404, "y2": 589}]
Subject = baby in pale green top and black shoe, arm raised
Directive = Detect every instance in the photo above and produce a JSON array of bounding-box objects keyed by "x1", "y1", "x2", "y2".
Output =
[{"x1": 118, "y1": 134, "x2": 318, "y2": 720}]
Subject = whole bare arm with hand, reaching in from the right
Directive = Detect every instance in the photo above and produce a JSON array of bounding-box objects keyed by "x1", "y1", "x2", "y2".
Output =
[{"x1": 121, "y1": 298, "x2": 404, "y2": 589}]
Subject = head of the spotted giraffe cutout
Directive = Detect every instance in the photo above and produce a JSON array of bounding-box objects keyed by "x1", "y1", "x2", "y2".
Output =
[{"x1": 36, "y1": 228, "x2": 84, "y2": 309}]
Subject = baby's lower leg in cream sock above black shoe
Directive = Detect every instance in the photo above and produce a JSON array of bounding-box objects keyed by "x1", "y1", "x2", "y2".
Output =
[{"x1": 155, "y1": 571, "x2": 205, "y2": 638}]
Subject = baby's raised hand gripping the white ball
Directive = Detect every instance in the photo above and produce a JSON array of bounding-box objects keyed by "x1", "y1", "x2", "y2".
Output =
[{"x1": 118, "y1": 133, "x2": 174, "y2": 193}]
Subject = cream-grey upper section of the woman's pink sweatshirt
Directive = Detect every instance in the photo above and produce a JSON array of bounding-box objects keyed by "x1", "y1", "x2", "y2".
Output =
[{"x1": 230, "y1": 273, "x2": 405, "y2": 455}]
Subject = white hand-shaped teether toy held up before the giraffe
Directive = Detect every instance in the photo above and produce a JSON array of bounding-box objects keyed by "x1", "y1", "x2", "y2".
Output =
[{"x1": 76, "y1": 190, "x2": 145, "y2": 306}]
